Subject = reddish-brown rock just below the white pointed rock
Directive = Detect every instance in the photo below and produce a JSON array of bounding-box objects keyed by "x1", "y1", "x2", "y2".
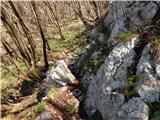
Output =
[{"x1": 35, "y1": 86, "x2": 80, "y2": 120}]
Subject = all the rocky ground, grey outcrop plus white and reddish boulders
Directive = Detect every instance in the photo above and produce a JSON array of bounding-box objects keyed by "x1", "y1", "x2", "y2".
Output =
[{"x1": 0, "y1": 1, "x2": 160, "y2": 120}]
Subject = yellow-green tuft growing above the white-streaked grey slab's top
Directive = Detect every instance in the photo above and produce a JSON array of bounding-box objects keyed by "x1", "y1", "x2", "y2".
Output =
[{"x1": 118, "y1": 31, "x2": 137, "y2": 41}]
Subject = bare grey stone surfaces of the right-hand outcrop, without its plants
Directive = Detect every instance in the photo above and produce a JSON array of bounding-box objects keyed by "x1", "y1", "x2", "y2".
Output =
[{"x1": 85, "y1": 2, "x2": 160, "y2": 120}]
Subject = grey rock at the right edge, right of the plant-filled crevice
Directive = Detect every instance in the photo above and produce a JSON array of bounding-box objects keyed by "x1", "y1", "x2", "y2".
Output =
[{"x1": 136, "y1": 45, "x2": 160, "y2": 102}]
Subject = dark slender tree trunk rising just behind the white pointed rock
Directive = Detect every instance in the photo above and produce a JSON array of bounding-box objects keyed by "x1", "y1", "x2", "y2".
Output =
[{"x1": 31, "y1": 1, "x2": 49, "y2": 69}]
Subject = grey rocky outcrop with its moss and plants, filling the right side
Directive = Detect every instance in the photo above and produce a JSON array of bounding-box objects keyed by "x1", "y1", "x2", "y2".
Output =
[{"x1": 77, "y1": 2, "x2": 160, "y2": 120}]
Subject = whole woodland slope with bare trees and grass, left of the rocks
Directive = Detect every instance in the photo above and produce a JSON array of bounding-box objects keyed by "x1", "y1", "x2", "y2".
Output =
[{"x1": 0, "y1": 1, "x2": 109, "y2": 120}]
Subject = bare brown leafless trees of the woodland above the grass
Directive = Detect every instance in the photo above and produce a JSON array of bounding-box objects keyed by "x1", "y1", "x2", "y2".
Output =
[{"x1": 1, "y1": 1, "x2": 109, "y2": 77}]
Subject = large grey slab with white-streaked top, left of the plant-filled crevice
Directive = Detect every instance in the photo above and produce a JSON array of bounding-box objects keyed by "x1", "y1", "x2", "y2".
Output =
[{"x1": 85, "y1": 37, "x2": 139, "y2": 120}]
